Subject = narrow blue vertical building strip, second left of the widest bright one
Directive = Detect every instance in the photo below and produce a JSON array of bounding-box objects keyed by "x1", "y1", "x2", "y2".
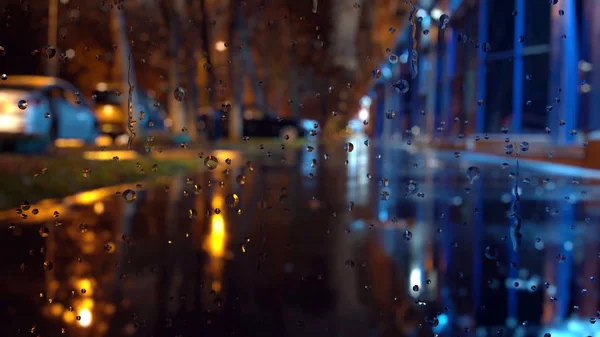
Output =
[{"x1": 473, "y1": 0, "x2": 488, "y2": 133}]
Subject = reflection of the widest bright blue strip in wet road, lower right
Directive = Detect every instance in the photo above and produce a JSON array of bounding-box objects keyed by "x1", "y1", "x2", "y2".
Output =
[{"x1": 554, "y1": 201, "x2": 575, "y2": 322}]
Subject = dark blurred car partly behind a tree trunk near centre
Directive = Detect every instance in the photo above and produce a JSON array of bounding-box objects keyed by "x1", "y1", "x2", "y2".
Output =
[{"x1": 199, "y1": 107, "x2": 307, "y2": 140}]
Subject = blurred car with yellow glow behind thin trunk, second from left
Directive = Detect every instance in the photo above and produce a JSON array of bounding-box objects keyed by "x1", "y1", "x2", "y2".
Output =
[{"x1": 92, "y1": 83, "x2": 166, "y2": 138}]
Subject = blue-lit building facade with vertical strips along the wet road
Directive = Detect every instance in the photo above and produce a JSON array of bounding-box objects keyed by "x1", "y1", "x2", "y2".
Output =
[{"x1": 369, "y1": 0, "x2": 600, "y2": 144}]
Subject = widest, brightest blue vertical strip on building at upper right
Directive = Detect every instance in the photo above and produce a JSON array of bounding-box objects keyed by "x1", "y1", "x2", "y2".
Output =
[{"x1": 552, "y1": 0, "x2": 579, "y2": 143}]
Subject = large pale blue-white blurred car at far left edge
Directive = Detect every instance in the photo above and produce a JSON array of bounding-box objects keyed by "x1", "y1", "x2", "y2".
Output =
[{"x1": 0, "y1": 75, "x2": 98, "y2": 151}]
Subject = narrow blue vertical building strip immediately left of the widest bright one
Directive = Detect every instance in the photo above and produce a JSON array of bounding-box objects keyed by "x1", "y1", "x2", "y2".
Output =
[{"x1": 511, "y1": 0, "x2": 525, "y2": 134}]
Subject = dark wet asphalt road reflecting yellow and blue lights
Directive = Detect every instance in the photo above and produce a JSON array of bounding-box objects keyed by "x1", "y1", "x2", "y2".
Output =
[{"x1": 0, "y1": 141, "x2": 600, "y2": 336}]
